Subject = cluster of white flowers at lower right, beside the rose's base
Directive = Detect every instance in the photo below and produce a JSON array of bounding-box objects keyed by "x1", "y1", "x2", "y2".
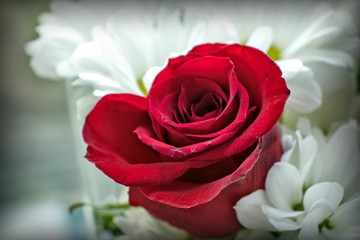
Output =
[{"x1": 235, "y1": 121, "x2": 360, "y2": 239}]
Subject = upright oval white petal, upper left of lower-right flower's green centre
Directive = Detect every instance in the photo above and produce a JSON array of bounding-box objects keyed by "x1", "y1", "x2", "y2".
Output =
[{"x1": 265, "y1": 162, "x2": 302, "y2": 211}]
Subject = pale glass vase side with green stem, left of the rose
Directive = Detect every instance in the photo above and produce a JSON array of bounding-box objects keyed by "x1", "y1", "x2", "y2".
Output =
[{"x1": 65, "y1": 79, "x2": 128, "y2": 239}]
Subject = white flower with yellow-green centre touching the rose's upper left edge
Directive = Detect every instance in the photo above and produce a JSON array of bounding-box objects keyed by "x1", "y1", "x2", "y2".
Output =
[{"x1": 69, "y1": 2, "x2": 188, "y2": 96}]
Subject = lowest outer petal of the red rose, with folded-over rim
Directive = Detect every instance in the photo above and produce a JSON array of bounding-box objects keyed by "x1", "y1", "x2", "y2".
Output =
[{"x1": 129, "y1": 124, "x2": 282, "y2": 237}]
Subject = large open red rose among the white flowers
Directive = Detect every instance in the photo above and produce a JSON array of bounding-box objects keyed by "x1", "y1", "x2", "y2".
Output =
[{"x1": 83, "y1": 44, "x2": 289, "y2": 237}]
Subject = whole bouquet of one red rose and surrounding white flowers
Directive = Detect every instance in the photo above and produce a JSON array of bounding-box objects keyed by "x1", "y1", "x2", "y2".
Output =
[{"x1": 26, "y1": 1, "x2": 360, "y2": 239}]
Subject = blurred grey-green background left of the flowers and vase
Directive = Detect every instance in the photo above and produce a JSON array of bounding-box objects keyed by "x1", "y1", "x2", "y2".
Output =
[{"x1": 0, "y1": 0, "x2": 84, "y2": 239}]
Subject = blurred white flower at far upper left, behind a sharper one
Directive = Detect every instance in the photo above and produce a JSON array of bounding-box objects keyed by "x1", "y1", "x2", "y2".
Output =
[{"x1": 25, "y1": 1, "x2": 121, "y2": 79}]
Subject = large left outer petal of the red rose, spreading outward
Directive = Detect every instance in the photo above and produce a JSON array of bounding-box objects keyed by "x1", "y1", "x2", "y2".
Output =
[{"x1": 83, "y1": 94, "x2": 189, "y2": 186}]
